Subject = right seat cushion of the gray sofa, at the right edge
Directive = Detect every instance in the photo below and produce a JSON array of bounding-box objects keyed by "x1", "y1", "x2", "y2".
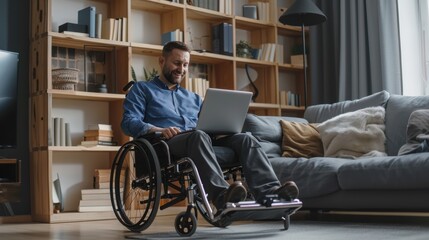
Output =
[{"x1": 338, "y1": 153, "x2": 429, "y2": 190}]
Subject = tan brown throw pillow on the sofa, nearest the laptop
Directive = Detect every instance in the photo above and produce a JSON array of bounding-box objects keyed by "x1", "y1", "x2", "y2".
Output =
[{"x1": 280, "y1": 120, "x2": 323, "y2": 158}]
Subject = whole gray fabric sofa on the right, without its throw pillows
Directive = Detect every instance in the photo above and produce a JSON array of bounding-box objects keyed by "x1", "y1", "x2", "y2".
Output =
[{"x1": 243, "y1": 91, "x2": 429, "y2": 211}]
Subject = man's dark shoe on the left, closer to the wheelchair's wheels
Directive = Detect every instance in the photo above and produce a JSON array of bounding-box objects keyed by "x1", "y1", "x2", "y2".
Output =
[{"x1": 214, "y1": 181, "x2": 247, "y2": 210}]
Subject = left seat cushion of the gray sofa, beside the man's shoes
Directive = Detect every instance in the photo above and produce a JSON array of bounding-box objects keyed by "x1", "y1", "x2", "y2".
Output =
[{"x1": 270, "y1": 157, "x2": 342, "y2": 198}]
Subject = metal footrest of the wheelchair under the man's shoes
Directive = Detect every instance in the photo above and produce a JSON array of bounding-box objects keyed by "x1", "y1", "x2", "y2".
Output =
[{"x1": 215, "y1": 196, "x2": 302, "y2": 221}]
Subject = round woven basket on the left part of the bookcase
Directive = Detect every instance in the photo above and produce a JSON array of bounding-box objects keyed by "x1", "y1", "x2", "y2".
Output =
[{"x1": 52, "y1": 68, "x2": 79, "y2": 90}]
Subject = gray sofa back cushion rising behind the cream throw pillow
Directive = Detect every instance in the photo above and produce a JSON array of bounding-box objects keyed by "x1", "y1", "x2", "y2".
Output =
[{"x1": 304, "y1": 91, "x2": 390, "y2": 123}]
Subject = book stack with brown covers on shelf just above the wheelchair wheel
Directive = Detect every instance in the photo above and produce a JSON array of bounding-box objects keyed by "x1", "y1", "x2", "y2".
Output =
[{"x1": 80, "y1": 124, "x2": 118, "y2": 147}]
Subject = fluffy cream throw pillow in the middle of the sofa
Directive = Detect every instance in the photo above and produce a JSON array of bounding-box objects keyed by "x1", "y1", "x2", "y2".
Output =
[{"x1": 317, "y1": 107, "x2": 386, "y2": 158}]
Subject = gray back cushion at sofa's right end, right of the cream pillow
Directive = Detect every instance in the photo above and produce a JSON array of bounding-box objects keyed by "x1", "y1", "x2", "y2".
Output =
[{"x1": 385, "y1": 95, "x2": 429, "y2": 156}]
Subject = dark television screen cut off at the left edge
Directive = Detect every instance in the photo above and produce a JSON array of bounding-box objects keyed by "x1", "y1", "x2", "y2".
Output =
[{"x1": 0, "y1": 50, "x2": 19, "y2": 149}]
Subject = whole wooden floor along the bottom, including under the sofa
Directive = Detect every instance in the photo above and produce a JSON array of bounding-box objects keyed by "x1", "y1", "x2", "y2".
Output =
[{"x1": 0, "y1": 207, "x2": 429, "y2": 240}]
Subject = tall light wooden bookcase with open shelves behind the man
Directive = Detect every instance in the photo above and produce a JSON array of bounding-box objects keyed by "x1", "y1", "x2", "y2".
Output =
[{"x1": 30, "y1": 0, "x2": 303, "y2": 222}]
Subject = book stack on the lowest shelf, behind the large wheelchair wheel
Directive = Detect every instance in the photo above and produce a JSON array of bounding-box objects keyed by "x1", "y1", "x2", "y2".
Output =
[{"x1": 79, "y1": 169, "x2": 125, "y2": 212}]
